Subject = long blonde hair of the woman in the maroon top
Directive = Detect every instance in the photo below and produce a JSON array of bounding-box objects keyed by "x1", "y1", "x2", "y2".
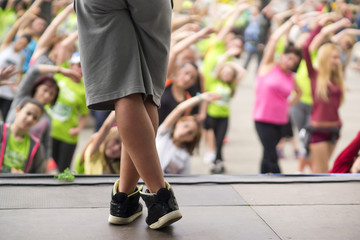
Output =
[{"x1": 315, "y1": 43, "x2": 345, "y2": 103}]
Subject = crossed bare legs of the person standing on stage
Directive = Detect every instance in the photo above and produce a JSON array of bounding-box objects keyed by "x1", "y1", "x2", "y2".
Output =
[{"x1": 115, "y1": 94, "x2": 165, "y2": 193}]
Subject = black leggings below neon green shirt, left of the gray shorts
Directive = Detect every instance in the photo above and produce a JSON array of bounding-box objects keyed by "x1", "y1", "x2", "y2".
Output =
[{"x1": 52, "y1": 138, "x2": 76, "y2": 172}]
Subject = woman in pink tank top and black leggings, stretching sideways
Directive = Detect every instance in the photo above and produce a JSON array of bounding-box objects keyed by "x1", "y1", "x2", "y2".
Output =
[{"x1": 253, "y1": 17, "x2": 301, "y2": 173}]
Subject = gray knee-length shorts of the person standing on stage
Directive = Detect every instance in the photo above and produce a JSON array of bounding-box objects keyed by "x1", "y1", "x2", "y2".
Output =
[{"x1": 74, "y1": 0, "x2": 172, "y2": 110}]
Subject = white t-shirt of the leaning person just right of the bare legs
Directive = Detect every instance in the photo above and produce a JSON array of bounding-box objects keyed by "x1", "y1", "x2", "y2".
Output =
[{"x1": 156, "y1": 125, "x2": 190, "y2": 174}]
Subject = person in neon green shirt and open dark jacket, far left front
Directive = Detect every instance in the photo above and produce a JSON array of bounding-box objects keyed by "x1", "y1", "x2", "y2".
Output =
[{"x1": 0, "y1": 98, "x2": 45, "y2": 173}]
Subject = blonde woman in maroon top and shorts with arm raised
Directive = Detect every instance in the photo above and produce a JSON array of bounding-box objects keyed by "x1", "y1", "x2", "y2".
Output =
[{"x1": 303, "y1": 14, "x2": 346, "y2": 173}]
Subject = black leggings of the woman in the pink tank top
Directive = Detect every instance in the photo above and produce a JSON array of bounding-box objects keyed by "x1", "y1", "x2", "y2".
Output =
[{"x1": 255, "y1": 122, "x2": 283, "y2": 173}]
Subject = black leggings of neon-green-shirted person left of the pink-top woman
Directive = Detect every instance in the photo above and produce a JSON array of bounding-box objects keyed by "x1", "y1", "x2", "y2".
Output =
[{"x1": 205, "y1": 116, "x2": 229, "y2": 161}]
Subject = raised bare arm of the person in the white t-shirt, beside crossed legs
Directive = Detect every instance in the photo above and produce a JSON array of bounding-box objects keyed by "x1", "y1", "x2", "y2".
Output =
[{"x1": 162, "y1": 92, "x2": 221, "y2": 132}]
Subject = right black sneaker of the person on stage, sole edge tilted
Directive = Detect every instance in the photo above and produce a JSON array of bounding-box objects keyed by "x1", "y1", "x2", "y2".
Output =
[{"x1": 140, "y1": 182, "x2": 182, "y2": 229}]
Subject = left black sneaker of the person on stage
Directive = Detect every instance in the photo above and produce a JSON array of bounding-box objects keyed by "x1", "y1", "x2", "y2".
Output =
[{"x1": 108, "y1": 180, "x2": 142, "y2": 225}]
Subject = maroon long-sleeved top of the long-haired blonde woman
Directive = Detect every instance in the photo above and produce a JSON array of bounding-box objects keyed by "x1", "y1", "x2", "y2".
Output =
[{"x1": 303, "y1": 26, "x2": 342, "y2": 122}]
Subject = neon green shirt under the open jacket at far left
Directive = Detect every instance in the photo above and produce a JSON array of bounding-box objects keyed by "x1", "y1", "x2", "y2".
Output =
[{"x1": 2, "y1": 133, "x2": 30, "y2": 173}]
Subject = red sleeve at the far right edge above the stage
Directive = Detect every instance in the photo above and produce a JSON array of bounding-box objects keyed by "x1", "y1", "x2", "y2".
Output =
[{"x1": 330, "y1": 131, "x2": 360, "y2": 173}]
